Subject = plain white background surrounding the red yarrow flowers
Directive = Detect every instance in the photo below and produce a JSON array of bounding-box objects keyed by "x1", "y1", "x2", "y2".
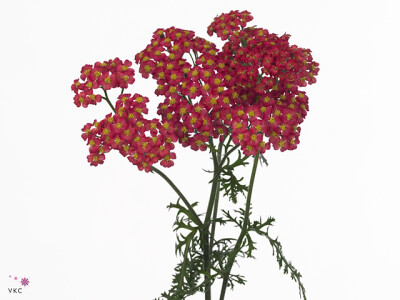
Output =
[{"x1": 0, "y1": 0, "x2": 400, "y2": 300}]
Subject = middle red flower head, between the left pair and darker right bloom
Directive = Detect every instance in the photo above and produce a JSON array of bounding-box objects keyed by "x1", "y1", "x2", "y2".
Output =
[{"x1": 136, "y1": 27, "x2": 227, "y2": 150}]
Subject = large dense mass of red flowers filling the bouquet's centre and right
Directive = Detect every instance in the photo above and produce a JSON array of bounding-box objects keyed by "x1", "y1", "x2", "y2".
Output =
[{"x1": 135, "y1": 11, "x2": 319, "y2": 155}]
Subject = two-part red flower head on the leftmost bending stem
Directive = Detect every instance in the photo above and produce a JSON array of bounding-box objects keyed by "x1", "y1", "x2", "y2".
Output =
[{"x1": 71, "y1": 58, "x2": 177, "y2": 172}]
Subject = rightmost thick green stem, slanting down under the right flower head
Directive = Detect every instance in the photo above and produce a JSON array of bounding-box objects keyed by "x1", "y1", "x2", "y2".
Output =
[{"x1": 219, "y1": 152, "x2": 260, "y2": 300}]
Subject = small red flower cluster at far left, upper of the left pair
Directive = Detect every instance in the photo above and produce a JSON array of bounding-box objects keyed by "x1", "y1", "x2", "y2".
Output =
[{"x1": 71, "y1": 58, "x2": 135, "y2": 108}]
